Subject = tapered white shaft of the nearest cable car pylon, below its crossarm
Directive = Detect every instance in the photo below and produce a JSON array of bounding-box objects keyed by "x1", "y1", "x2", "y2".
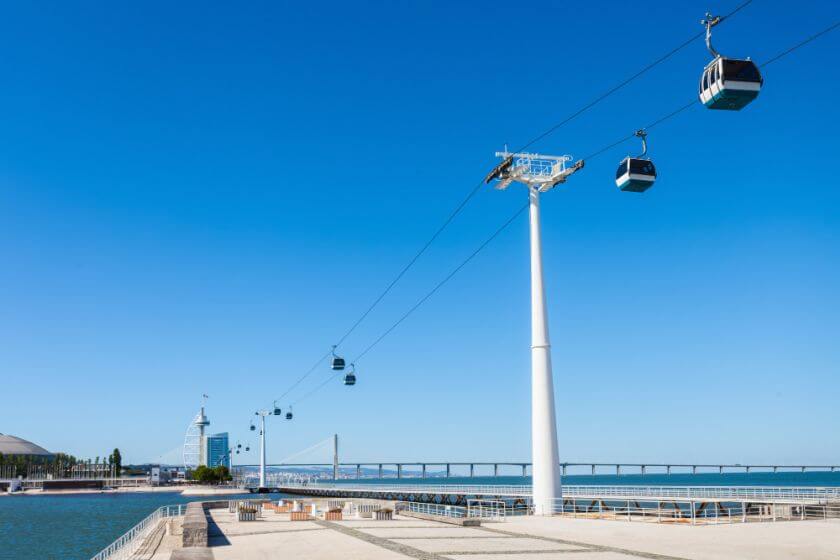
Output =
[{"x1": 528, "y1": 187, "x2": 562, "y2": 515}]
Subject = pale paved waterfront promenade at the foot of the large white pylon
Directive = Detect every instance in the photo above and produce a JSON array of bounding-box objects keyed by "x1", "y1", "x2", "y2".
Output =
[{"x1": 142, "y1": 509, "x2": 840, "y2": 560}]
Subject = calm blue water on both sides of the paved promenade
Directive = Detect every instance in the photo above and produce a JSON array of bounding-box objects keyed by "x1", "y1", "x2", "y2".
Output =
[{"x1": 0, "y1": 472, "x2": 840, "y2": 560}]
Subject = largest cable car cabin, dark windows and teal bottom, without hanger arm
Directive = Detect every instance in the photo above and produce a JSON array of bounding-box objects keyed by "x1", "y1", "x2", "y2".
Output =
[{"x1": 700, "y1": 56, "x2": 764, "y2": 111}]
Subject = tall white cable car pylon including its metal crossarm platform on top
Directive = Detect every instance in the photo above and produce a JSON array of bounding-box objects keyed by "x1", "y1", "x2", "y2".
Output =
[{"x1": 485, "y1": 150, "x2": 583, "y2": 515}]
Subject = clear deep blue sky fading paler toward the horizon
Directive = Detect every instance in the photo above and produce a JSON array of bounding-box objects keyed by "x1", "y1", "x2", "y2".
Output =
[{"x1": 0, "y1": 0, "x2": 840, "y2": 463}]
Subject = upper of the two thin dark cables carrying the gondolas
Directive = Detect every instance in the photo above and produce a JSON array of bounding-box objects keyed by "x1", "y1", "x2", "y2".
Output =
[{"x1": 262, "y1": 0, "x2": 753, "y2": 412}]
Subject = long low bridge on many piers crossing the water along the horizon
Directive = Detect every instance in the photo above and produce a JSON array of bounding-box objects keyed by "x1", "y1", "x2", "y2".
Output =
[{"x1": 236, "y1": 461, "x2": 840, "y2": 479}]
